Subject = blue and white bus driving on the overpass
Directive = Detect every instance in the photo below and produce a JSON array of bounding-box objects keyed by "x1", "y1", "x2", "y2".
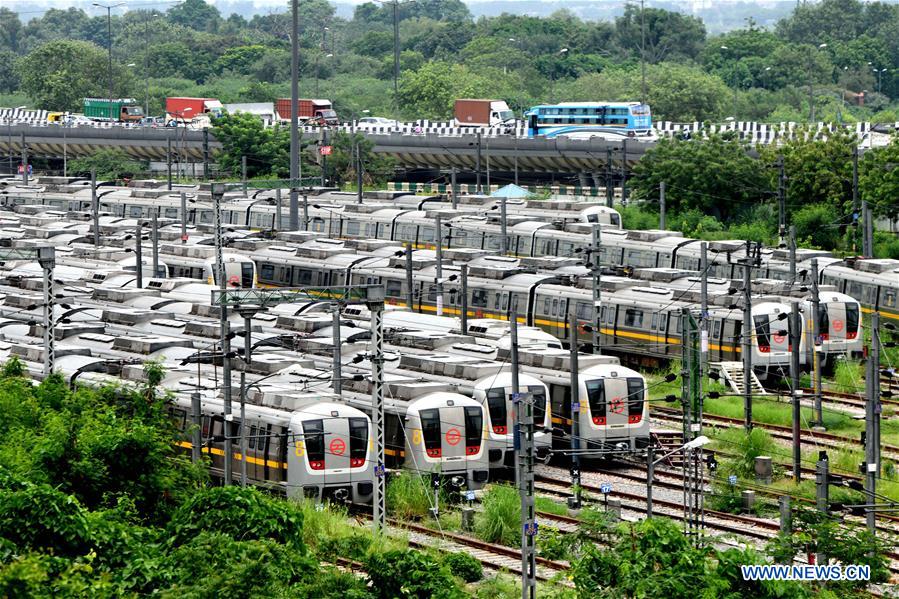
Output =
[{"x1": 524, "y1": 102, "x2": 654, "y2": 137}]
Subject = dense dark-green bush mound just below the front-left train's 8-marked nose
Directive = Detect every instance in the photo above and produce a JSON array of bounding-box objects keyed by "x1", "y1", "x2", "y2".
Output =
[{"x1": 168, "y1": 486, "x2": 304, "y2": 551}]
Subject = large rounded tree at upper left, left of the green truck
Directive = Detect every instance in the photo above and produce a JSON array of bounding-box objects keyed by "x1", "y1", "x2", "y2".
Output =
[{"x1": 16, "y1": 40, "x2": 130, "y2": 111}]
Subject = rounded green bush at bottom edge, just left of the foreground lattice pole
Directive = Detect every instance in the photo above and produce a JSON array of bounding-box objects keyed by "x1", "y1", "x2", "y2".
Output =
[{"x1": 365, "y1": 551, "x2": 464, "y2": 599}]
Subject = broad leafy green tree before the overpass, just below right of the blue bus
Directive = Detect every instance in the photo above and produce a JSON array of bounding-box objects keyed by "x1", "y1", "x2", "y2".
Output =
[{"x1": 631, "y1": 135, "x2": 771, "y2": 222}]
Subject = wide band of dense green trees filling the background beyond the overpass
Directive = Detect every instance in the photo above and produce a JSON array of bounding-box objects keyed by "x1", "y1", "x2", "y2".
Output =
[{"x1": 0, "y1": 0, "x2": 899, "y2": 122}]
